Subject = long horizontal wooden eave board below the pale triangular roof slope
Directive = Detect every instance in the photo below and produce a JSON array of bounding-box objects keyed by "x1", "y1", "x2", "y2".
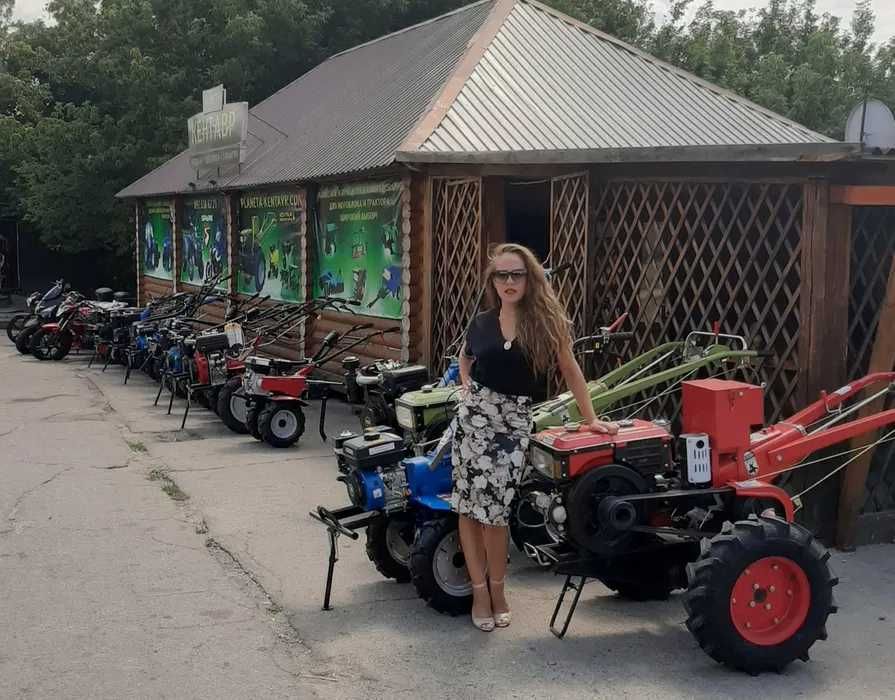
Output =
[{"x1": 396, "y1": 142, "x2": 861, "y2": 165}]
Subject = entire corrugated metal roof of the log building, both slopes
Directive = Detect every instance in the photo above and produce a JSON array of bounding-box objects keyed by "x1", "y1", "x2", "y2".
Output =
[{"x1": 118, "y1": 0, "x2": 841, "y2": 197}]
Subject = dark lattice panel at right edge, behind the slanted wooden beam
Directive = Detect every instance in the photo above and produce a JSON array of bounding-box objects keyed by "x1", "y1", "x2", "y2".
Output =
[{"x1": 848, "y1": 207, "x2": 895, "y2": 513}]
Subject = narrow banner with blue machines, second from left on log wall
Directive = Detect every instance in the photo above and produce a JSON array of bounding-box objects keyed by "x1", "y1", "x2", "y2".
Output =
[{"x1": 180, "y1": 196, "x2": 227, "y2": 288}]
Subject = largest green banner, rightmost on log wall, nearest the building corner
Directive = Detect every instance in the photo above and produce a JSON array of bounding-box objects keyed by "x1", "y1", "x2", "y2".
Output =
[{"x1": 313, "y1": 181, "x2": 403, "y2": 318}]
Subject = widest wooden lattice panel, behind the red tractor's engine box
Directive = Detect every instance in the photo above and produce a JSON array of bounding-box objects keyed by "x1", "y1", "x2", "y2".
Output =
[{"x1": 590, "y1": 181, "x2": 802, "y2": 420}]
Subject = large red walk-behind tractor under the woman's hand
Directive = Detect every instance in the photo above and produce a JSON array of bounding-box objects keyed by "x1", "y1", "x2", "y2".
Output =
[{"x1": 529, "y1": 373, "x2": 895, "y2": 674}]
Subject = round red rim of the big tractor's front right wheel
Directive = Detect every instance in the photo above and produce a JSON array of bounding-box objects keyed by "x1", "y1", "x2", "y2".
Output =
[{"x1": 730, "y1": 557, "x2": 811, "y2": 646}]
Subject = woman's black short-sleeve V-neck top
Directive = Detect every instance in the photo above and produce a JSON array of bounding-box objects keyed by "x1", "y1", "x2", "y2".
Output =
[{"x1": 466, "y1": 310, "x2": 544, "y2": 399}]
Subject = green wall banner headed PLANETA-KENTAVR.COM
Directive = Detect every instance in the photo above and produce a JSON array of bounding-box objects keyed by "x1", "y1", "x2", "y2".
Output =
[{"x1": 236, "y1": 191, "x2": 303, "y2": 301}]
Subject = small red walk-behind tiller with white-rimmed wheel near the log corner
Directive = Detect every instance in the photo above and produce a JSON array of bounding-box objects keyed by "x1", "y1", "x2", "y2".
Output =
[{"x1": 243, "y1": 324, "x2": 400, "y2": 447}]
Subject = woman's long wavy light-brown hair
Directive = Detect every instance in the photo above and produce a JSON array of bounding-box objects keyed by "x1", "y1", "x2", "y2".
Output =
[{"x1": 485, "y1": 243, "x2": 572, "y2": 374}]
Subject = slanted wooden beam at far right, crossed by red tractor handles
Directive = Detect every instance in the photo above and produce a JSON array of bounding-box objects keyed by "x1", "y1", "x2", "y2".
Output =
[{"x1": 836, "y1": 257, "x2": 895, "y2": 550}]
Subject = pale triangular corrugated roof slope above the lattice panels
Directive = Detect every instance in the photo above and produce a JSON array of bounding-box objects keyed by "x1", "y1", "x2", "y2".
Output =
[{"x1": 419, "y1": 0, "x2": 833, "y2": 154}]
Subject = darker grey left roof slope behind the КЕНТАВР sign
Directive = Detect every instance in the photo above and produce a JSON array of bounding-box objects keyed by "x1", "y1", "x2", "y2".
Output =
[{"x1": 118, "y1": 0, "x2": 494, "y2": 197}]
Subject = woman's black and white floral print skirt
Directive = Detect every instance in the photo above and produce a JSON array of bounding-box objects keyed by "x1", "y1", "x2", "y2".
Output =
[{"x1": 451, "y1": 382, "x2": 531, "y2": 527}]
